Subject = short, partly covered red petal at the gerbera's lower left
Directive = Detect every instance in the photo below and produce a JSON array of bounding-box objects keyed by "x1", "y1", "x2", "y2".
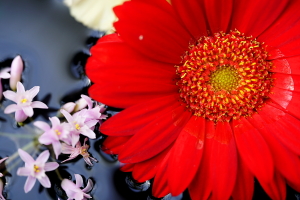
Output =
[{"x1": 132, "y1": 145, "x2": 173, "y2": 183}]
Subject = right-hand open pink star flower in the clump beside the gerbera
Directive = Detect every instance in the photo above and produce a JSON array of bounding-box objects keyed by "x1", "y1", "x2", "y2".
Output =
[{"x1": 60, "y1": 110, "x2": 98, "y2": 147}]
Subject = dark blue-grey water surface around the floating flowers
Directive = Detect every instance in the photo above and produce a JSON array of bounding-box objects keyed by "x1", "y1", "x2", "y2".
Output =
[{"x1": 0, "y1": 0, "x2": 300, "y2": 200}]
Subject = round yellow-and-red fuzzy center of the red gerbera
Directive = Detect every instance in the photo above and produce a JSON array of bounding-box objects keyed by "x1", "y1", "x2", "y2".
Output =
[{"x1": 176, "y1": 30, "x2": 273, "y2": 122}]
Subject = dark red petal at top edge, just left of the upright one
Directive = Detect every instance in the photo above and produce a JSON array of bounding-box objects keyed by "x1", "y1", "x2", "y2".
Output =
[{"x1": 172, "y1": 0, "x2": 208, "y2": 40}]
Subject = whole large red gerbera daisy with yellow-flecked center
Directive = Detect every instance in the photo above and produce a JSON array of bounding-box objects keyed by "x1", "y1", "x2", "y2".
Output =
[{"x1": 86, "y1": 0, "x2": 300, "y2": 200}]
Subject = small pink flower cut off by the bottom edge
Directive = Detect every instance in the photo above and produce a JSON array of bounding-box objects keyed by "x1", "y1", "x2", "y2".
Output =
[{"x1": 61, "y1": 174, "x2": 94, "y2": 200}]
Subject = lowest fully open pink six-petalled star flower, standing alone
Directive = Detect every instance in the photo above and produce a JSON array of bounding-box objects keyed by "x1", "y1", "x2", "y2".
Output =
[{"x1": 17, "y1": 149, "x2": 59, "y2": 193}]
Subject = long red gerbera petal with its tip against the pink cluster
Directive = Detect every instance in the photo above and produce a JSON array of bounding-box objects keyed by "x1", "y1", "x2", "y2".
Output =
[{"x1": 100, "y1": 94, "x2": 179, "y2": 136}]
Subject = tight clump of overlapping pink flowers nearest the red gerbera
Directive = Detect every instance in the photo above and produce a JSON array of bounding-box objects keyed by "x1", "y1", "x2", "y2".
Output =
[{"x1": 34, "y1": 95, "x2": 107, "y2": 162}]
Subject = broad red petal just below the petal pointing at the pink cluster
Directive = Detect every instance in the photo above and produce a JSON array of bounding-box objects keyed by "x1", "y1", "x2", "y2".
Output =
[{"x1": 119, "y1": 105, "x2": 191, "y2": 163}]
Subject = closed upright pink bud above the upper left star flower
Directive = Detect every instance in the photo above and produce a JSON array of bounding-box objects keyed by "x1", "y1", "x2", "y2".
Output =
[{"x1": 9, "y1": 56, "x2": 24, "y2": 91}]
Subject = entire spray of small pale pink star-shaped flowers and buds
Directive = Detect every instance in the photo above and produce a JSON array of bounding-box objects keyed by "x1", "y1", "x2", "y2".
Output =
[{"x1": 0, "y1": 56, "x2": 107, "y2": 200}]
